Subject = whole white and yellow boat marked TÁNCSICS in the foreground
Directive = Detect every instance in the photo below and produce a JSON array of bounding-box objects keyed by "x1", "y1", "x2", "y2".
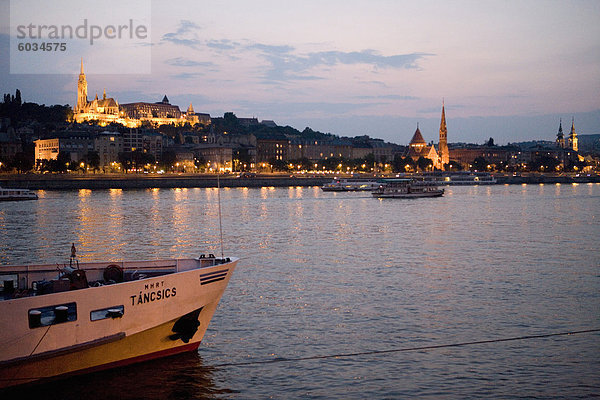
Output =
[{"x1": 0, "y1": 254, "x2": 238, "y2": 387}]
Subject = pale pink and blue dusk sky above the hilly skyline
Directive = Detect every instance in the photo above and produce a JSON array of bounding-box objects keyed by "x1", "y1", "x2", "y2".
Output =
[{"x1": 0, "y1": 0, "x2": 600, "y2": 143}]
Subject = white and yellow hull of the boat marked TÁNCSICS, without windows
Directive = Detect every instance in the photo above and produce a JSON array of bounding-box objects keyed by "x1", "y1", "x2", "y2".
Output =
[{"x1": 0, "y1": 259, "x2": 237, "y2": 387}]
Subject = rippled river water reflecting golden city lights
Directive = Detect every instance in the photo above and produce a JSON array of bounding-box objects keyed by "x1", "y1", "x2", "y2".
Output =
[{"x1": 0, "y1": 184, "x2": 600, "y2": 399}]
